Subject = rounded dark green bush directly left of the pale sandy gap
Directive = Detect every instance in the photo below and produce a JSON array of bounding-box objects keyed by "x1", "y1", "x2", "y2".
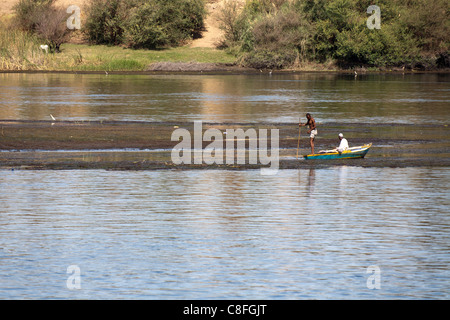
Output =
[{"x1": 85, "y1": 0, "x2": 206, "y2": 49}]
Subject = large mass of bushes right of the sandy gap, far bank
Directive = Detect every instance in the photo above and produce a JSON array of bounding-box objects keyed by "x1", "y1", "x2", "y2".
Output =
[{"x1": 222, "y1": 0, "x2": 450, "y2": 69}]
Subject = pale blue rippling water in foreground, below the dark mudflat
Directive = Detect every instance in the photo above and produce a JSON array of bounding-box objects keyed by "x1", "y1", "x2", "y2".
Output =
[{"x1": 0, "y1": 167, "x2": 450, "y2": 299}]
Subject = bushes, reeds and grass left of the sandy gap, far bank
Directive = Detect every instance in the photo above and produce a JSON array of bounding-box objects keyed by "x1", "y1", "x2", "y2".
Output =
[{"x1": 0, "y1": 0, "x2": 235, "y2": 71}]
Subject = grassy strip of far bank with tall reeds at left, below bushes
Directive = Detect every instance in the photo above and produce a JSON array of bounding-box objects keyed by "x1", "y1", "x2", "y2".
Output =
[{"x1": 0, "y1": 23, "x2": 450, "y2": 75}]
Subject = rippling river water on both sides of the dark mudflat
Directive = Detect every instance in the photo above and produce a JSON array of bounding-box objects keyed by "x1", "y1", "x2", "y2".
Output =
[{"x1": 0, "y1": 74, "x2": 450, "y2": 299}]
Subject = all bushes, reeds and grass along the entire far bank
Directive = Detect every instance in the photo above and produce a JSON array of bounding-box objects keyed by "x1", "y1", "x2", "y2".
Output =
[{"x1": 0, "y1": 0, "x2": 450, "y2": 71}]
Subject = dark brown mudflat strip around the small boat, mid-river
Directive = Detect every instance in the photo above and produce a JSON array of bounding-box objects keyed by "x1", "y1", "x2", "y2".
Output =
[{"x1": 0, "y1": 120, "x2": 450, "y2": 170}]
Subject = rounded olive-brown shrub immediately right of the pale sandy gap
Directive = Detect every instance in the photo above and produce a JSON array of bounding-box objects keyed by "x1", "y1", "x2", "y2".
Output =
[{"x1": 221, "y1": 0, "x2": 314, "y2": 69}]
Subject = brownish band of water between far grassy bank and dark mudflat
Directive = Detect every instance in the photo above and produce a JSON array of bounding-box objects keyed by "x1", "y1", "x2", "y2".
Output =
[{"x1": 0, "y1": 74, "x2": 450, "y2": 124}]
